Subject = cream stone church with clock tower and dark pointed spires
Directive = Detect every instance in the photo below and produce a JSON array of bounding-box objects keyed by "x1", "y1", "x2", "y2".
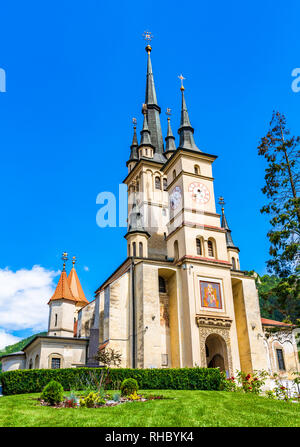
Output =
[{"x1": 2, "y1": 44, "x2": 299, "y2": 376}]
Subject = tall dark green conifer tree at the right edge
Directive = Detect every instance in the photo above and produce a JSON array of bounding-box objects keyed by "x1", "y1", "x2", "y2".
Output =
[{"x1": 258, "y1": 112, "x2": 300, "y2": 322}]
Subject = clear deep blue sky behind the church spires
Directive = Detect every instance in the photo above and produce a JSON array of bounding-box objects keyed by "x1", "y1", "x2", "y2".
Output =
[{"x1": 0, "y1": 0, "x2": 300, "y2": 344}]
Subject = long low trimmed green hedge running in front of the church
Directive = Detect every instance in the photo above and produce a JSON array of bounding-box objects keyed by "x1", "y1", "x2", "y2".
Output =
[{"x1": 0, "y1": 367, "x2": 221, "y2": 395}]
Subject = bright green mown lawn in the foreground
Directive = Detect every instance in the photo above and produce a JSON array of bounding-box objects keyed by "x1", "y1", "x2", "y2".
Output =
[{"x1": 0, "y1": 390, "x2": 300, "y2": 427}]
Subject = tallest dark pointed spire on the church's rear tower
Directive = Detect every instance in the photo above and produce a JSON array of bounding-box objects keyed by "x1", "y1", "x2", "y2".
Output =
[{"x1": 145, "y1": 44, "x2": 166, "y2": 163}]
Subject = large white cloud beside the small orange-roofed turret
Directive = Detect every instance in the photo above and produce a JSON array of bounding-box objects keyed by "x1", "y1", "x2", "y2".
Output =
[{"x1": 0, "y1": 265, "x2": 59, "y2": 336}]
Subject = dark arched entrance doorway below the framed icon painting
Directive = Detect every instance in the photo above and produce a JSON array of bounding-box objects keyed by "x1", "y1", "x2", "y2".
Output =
[{"x1": 205, "y1": 334, "x2": 229, "y2": 374}]
